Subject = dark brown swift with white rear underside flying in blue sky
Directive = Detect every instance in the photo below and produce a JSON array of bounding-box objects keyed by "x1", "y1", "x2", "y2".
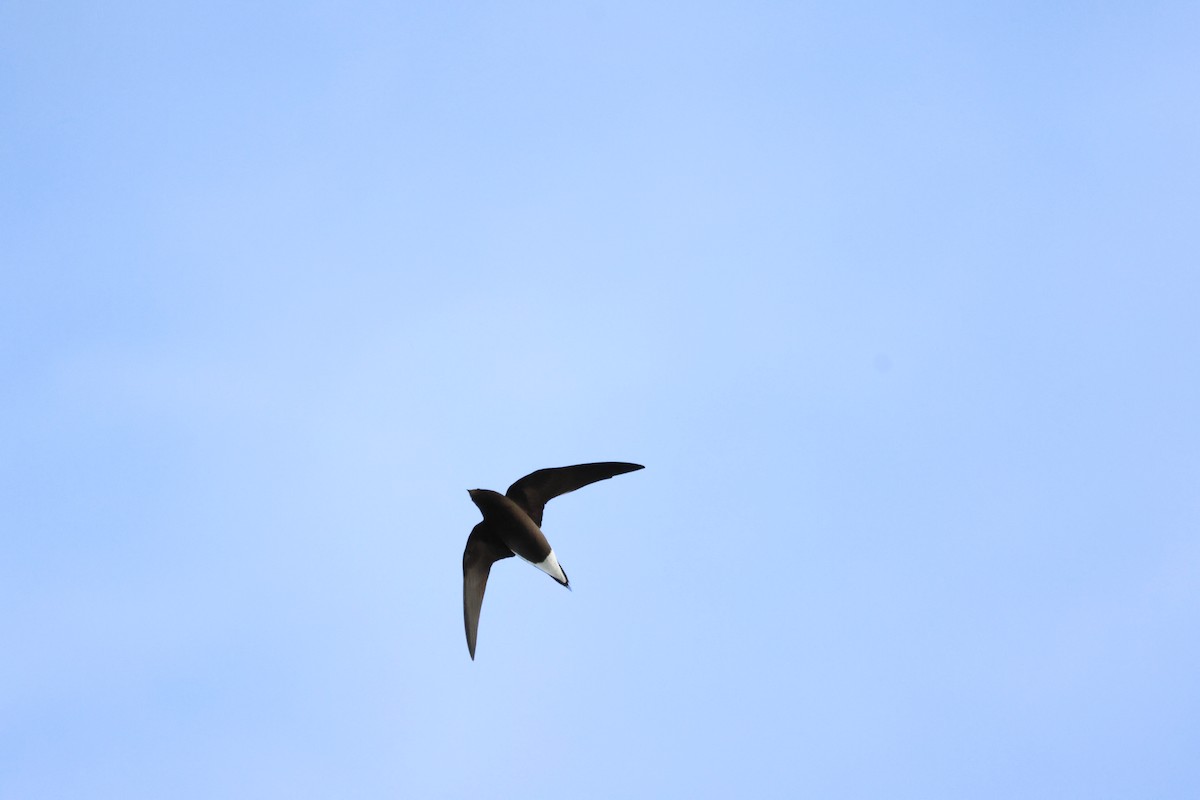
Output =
[{"x1": 462, "y1": 461, "x2": 644, "y2": 661}]
